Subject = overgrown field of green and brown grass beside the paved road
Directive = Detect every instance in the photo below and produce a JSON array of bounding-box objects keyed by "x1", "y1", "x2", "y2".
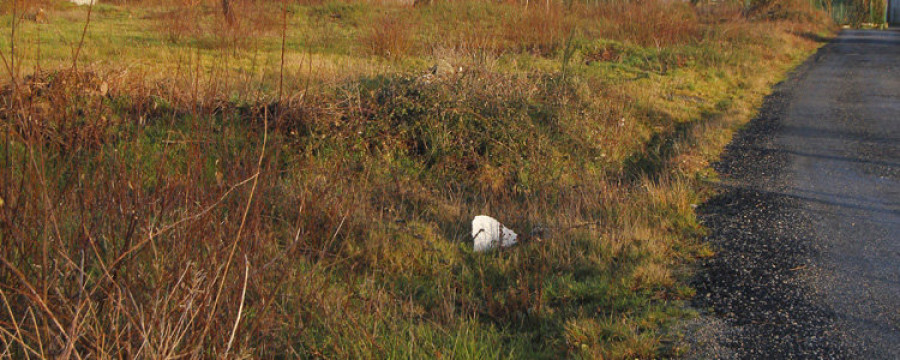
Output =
[{"x1": 0, "y1": 1, "x2": 830, "y2": 358}]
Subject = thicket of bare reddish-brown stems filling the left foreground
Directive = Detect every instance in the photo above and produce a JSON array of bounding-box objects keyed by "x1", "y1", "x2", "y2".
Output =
[{"x1": 0, "y1": 67, "x2": 263, "y2": 358}]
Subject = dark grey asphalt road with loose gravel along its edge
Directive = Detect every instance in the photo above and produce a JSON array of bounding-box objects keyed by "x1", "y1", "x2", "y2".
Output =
[{"x1": 688, "y1": 30, "x2": 900, "y2": 359}]
